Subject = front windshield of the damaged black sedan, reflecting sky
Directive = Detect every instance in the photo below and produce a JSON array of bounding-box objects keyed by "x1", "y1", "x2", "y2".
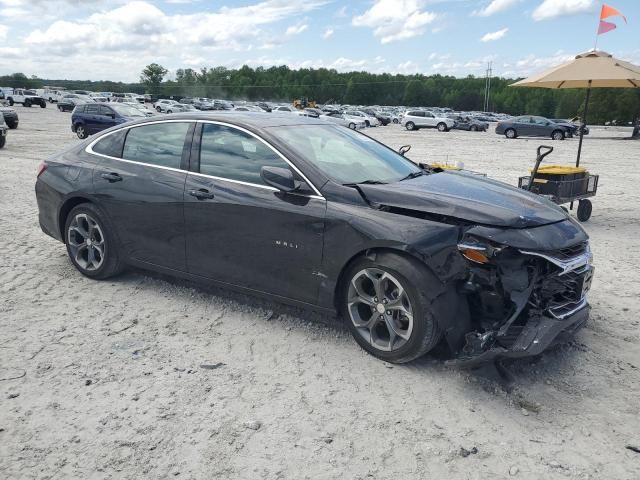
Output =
[{"x1": 269, "y1": 125, "x2": 421, "y2": 184}]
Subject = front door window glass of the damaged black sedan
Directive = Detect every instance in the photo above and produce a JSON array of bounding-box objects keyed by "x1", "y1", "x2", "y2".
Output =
[{"x1": 200, "y1": 123, "x2": 289, "y2": 185}]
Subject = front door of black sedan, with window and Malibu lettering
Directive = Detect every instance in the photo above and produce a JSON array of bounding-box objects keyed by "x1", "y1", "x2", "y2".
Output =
[{"x1": 184, "y1": 123, "x2": 326, "y2": 303}]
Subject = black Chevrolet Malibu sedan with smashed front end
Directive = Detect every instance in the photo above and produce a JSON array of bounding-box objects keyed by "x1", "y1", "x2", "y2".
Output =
[{"x1": 36, "y1": 112, "x2": 592, "y2": 364}]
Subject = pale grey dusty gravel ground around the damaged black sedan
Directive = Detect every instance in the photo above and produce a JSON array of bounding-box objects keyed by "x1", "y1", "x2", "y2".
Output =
[{"x1": 0, "y1": 106, "x2": 640, "y2": 479}]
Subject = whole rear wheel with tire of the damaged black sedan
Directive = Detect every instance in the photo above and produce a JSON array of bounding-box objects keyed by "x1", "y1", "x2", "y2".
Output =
[{"x1": 64, "y1": 203, "x2": 123, "y2": 280}]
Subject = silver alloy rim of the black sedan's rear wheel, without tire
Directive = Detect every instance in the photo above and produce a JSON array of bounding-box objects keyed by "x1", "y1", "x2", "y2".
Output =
[{"x1": 67, "y1": 213, "x2": 105, "y2": 271}]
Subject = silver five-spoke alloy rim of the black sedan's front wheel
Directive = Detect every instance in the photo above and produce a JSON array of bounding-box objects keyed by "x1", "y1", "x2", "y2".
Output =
[{"x1": 347, "y1": 268, "x2": 413, "y2": 351}]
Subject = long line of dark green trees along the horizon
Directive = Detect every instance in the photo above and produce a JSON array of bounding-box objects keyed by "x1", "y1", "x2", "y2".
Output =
[{"x1": 0, "y1": 64, "x2": 640, "y2": 124}]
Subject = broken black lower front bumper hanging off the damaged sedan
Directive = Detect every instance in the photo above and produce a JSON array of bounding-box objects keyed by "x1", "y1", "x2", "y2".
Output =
[{"x1": 447, "y1": 304, "x2": 591, "y2": 367}]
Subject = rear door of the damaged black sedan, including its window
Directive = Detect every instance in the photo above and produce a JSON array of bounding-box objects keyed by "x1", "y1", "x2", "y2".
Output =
[{"x1": 89, "y1": 121, "x2": 195, "y2": 271}]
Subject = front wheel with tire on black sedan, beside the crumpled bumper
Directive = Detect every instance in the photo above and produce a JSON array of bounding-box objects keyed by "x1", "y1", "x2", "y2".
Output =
[{"x1": 341, "y1": 253, "x2": 441, "y2": 363}]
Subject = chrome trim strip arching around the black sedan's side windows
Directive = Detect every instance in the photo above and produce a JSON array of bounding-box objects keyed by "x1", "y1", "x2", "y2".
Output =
[{"x1": 84, "y1": 119, "x2": 324, "y2": 200}]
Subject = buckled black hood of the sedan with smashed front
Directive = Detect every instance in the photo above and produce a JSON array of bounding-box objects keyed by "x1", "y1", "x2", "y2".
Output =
[{"x1": 358, "y1": 172, "x2": 567, "y2": 228}]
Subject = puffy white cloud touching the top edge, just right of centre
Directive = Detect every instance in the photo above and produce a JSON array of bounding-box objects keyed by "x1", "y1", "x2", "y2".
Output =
[{"x1": 351, "y1": 0, "x2": 437, "y2": 44}]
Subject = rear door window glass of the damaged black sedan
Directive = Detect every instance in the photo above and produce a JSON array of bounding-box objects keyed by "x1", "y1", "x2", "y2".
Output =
[{"x1": 122, "y1": 122, "x2": 190, "y2": 168}]
